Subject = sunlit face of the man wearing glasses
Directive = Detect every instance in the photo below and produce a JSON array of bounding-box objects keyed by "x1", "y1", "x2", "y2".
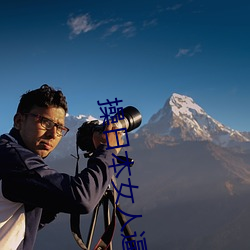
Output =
[{"x1": 14, "y1": 106, "x2": 66, "y2": 158}]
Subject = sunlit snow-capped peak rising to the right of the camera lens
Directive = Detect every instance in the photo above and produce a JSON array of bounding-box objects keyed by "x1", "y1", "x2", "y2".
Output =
[{"x1": 139, "y1": 93, "x2": 250, "y2": 146}]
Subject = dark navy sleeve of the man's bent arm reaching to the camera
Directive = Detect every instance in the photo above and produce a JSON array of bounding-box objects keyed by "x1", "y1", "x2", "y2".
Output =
[{"x1": 1, "y1": 144, "x2": 115, "y2": 213}]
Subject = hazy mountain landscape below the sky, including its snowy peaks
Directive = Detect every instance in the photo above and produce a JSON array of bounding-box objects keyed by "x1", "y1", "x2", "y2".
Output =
[{"x1": 36, "y1": 93, "x2": 250, "y2": 250}]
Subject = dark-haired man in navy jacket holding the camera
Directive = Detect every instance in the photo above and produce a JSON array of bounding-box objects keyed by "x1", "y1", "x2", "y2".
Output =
[{"x1": 0, "y1": 84, "x2": 123, "y2": 250}]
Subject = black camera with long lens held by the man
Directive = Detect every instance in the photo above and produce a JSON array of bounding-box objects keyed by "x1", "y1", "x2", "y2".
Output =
[{"x1": 76, "y1": 106, "x2": 142, "y2": 153}]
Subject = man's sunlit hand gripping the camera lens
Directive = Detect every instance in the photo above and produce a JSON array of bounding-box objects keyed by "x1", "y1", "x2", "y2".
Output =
[{"x1": 93, "y1": 123, "x2": 124, "y2": 154}]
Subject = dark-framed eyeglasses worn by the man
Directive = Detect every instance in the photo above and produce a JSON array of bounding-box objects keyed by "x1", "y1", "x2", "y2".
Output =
[{"x1": 24, "y1": 113, "x2": 69, "y2": 136}]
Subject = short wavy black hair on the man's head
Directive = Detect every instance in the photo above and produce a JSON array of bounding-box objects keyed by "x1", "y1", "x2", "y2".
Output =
[{"x1": 17, "y1": 84, "x2": 68, "y2": 114}]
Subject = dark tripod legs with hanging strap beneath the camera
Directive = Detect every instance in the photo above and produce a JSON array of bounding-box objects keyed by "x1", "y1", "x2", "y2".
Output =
[{"x1": 70, "y1": 177, "x2": 134, "y2": 250}]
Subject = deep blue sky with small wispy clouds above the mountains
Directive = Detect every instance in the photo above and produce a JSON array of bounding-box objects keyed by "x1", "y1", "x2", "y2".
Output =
[{"x1": 0, "y1": 0, "x2": 250, "y2": 133}]
